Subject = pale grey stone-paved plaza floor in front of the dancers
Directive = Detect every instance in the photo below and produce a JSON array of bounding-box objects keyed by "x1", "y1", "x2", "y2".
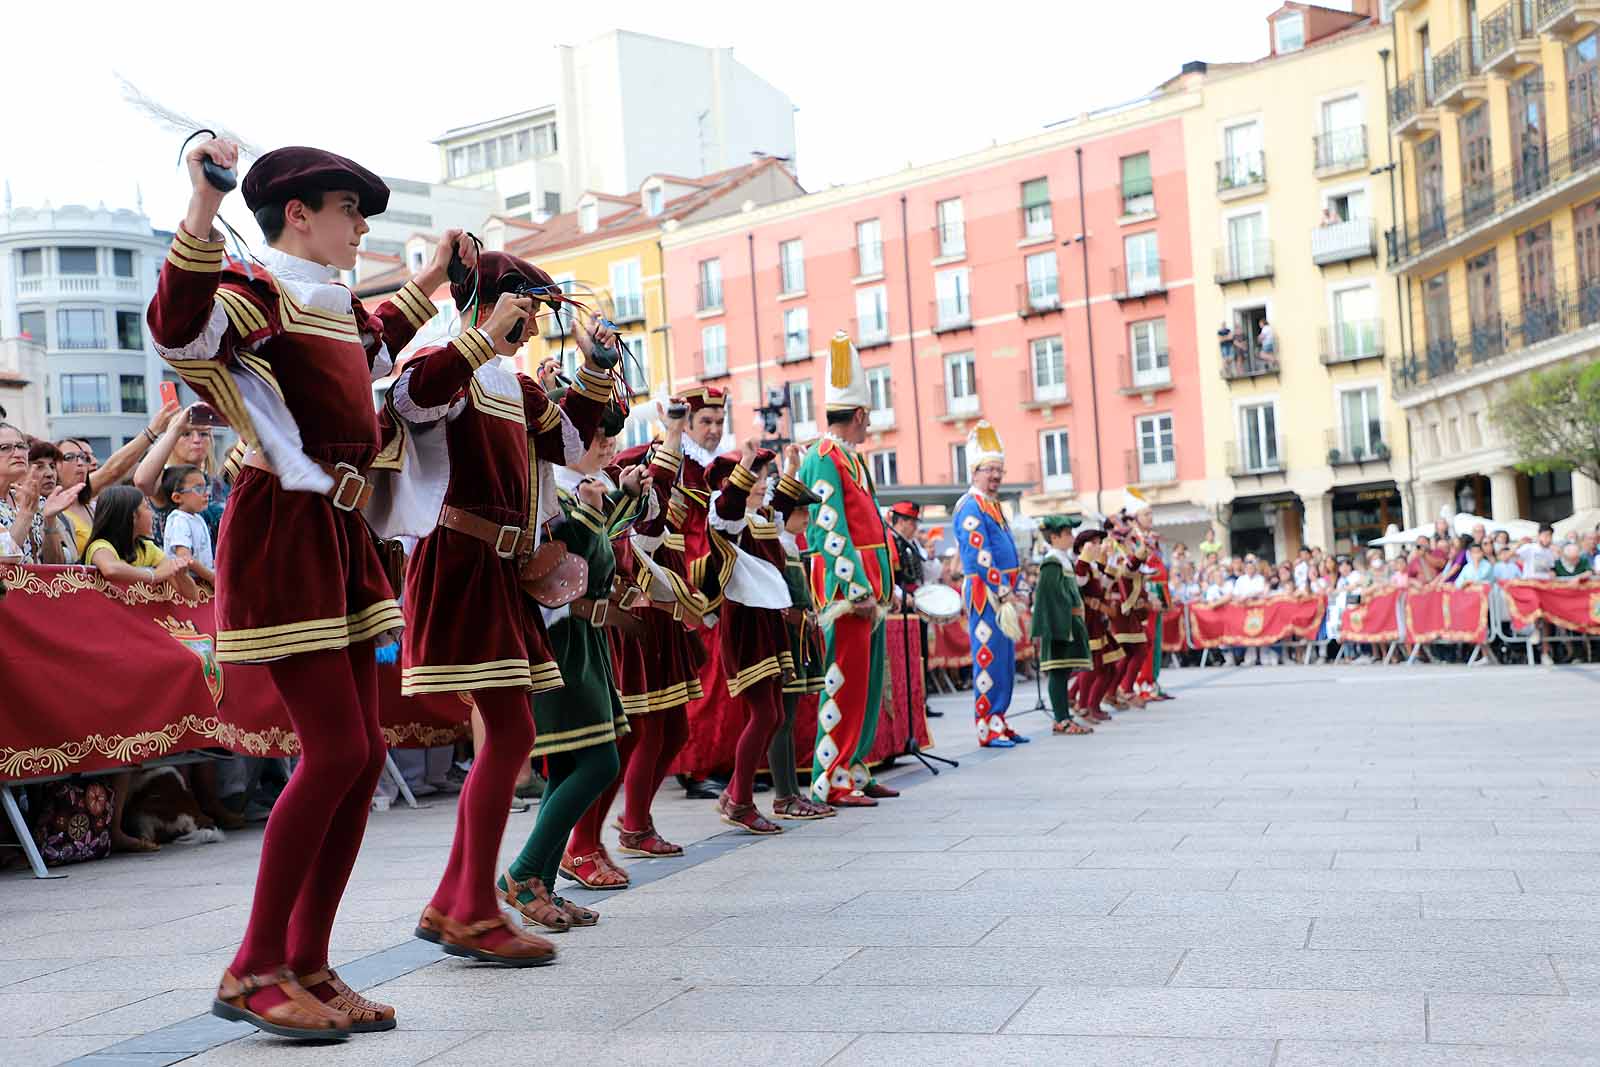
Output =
[{"x1": 9, "y1": 665, "x2": 1600, "y2": 1067}]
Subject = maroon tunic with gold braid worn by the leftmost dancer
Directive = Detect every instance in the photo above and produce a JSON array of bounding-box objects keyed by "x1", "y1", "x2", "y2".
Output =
[{"x1": 147, "y1": 227, "x2": 434, "y2": 662}]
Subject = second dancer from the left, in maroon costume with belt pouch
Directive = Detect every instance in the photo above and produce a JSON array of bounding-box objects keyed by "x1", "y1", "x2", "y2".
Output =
[{"x1": 389, "y1": 253, "x2": 611, "y2": 966}]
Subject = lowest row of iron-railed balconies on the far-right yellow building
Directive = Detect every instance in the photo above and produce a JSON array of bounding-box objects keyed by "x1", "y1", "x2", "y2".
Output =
[{"x1": 1389, "y1": 278, "x2": 1600, "y2": 397}]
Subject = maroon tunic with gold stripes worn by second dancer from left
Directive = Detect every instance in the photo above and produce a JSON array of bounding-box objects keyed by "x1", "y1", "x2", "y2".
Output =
[{"x1": 389, "y1": 330, "x2": 611, "y2": 696}]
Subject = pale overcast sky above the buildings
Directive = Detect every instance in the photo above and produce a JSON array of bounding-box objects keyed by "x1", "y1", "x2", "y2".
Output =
[{"x1": 0, "y1": 0, "x2": 1324, "y2": 235}]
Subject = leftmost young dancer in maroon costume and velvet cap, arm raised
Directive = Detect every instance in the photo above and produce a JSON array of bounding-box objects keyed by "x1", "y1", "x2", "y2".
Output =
[{"x1": 149, "y1": 139, "x2": 454, "y2": 1040}]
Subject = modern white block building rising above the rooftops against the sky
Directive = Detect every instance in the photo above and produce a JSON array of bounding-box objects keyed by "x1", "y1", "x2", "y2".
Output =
[{"x1": 434, "y1": 30, "x2": 795, "y2": 221}]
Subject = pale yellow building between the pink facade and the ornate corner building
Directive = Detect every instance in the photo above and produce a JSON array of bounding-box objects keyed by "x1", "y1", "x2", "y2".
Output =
[{"x1": 1181, "y1": 14, "x2": 1408, "y2": 560}]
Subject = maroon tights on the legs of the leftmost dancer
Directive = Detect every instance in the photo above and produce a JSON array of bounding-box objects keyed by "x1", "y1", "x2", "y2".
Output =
[{"x1": 229, "y1": 641, "x2": 386, "y2": 1006}]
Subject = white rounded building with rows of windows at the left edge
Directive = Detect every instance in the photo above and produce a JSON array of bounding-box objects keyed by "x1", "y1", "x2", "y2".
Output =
[{"x1": 0, "y1": 203, "x2": 171, "y2": 456}]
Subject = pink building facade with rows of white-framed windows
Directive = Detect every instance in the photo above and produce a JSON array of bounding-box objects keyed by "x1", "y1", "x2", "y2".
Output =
[{"x1": 662, "y1": 94, "x2": 1214, "y2": 525}]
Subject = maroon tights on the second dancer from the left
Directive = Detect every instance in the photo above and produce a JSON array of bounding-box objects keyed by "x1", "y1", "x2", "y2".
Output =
[{"x1": 432, "y1": 688, "x2": 533, "y2": 940}]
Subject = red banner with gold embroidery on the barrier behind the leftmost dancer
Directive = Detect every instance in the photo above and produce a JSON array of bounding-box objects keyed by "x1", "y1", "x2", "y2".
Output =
[{"x1": 0, "y1": 565, "x2": 467, "y2": 779}]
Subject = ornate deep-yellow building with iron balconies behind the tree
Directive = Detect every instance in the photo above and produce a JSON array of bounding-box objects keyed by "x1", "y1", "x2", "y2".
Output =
[{"x1": 1387, "y1": 0, "x2": 1600, "y2": 522}]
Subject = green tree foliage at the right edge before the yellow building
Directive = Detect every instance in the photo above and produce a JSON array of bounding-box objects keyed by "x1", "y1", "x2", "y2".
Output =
[{"x1": 1490, "y1": 362, "x2": 1600, "y2": 482}]
